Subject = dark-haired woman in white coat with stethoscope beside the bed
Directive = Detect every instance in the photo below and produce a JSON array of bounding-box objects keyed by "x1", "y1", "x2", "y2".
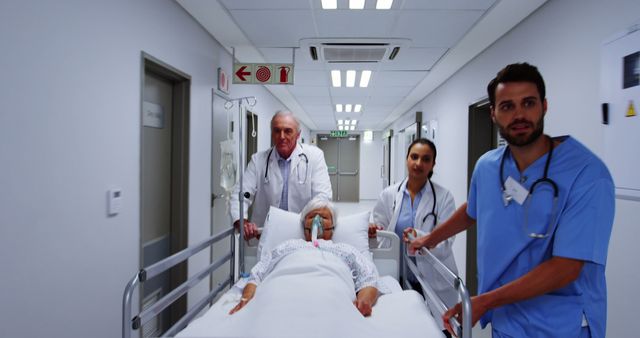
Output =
[{"x1": 369, "y1": 138, "x2": 458, "y2": 332}]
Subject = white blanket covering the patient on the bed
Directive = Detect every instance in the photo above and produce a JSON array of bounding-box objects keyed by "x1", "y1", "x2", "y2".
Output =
[{"x1": 179, "y1": 244, "x2": 441, "y2": 337}]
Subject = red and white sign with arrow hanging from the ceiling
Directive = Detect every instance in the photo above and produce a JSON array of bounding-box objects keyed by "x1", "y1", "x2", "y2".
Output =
[{"x1": 233, "y1": 63, "x2": 293, "y2": 85}]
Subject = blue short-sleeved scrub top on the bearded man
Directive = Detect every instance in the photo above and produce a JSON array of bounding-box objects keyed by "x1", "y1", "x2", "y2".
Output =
[{"x1": 467, "y1": 137, "x2": 615, "y2": 337}]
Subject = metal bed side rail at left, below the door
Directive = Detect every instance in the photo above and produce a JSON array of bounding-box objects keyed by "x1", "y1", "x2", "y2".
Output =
[{"x1": 122, "y1": 227, "x2": 235, "y2": 338}]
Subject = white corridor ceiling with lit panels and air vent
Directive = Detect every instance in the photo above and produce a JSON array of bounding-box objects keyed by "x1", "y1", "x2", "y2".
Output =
[{"x1": 176, "y1": 0, "x2": 546, "y2": 130}]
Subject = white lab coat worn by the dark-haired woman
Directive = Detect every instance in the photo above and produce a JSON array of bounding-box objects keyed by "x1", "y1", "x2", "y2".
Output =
[{"x1": 369, "y1": 180, "x2": 458, "y2": 325}]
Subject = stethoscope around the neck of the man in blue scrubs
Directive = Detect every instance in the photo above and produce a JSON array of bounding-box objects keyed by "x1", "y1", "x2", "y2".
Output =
[{"x1": 500, "y1": 137, "x2": 558, "y2": 238}]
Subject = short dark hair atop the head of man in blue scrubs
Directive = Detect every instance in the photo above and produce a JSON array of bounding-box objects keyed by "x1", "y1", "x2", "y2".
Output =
[{"x1": 487, "y1": 62, "x2": 546, "y2": 106}]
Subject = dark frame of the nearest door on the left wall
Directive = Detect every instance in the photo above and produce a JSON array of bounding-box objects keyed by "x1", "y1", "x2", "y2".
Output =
[{"x1": 138, "y1": 51, "x2": 191, "y2": 332}]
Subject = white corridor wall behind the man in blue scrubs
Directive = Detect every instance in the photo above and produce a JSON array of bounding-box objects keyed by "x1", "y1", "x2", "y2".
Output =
[{"x1": 384, "y1": 0, "x2": 640, "y2": 337}]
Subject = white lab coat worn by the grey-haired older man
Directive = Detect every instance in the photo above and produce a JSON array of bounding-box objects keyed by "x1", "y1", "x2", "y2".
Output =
[{"x1": 229, "y1": 143, "x2": 332, "y2": 227}]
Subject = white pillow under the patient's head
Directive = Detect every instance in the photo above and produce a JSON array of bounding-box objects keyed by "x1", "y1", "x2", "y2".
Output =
[{"x1": 258, "y1": 206, "x2": 369, "y2": 257}]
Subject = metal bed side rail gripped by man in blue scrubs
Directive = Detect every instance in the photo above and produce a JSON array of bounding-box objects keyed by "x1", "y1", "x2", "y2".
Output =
[{"x1": 401, "y1": 243, "x2": 473, "y2": 338}]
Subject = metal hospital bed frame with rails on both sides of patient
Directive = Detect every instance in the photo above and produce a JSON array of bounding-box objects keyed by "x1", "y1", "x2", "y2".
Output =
[{"x1": 122, "y1": 227, "x2": 472, "y2": 338}]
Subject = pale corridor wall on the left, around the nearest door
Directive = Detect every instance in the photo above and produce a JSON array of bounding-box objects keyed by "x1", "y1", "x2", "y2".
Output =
[{"x1": 0, "y1": 0, "x2": 290, "y2": 338}]
